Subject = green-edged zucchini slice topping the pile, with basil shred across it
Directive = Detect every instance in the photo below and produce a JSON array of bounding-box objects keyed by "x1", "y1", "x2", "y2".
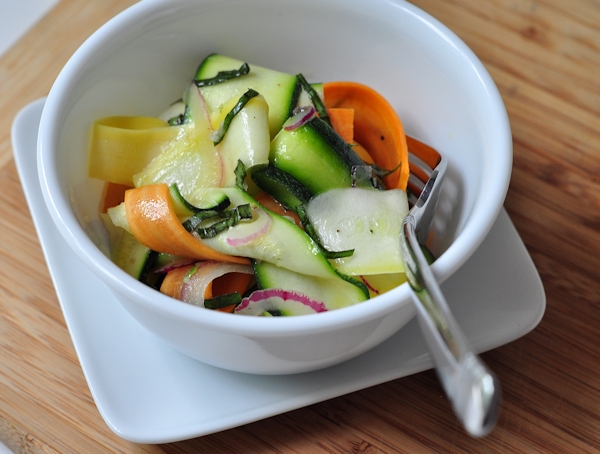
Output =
[{"x1": 195, "y1": 54, "x2": 299, "y2": 137}]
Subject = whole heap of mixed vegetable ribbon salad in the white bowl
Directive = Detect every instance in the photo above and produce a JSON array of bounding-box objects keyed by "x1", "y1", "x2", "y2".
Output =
[{"x1": 89, "y1": 54, "x2": 424, "y2": 316}]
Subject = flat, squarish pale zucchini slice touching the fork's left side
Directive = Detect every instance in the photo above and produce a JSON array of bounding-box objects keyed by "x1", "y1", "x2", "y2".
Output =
[{"x1": 306, "y1": 188, "x2": 408, "y2": 276}]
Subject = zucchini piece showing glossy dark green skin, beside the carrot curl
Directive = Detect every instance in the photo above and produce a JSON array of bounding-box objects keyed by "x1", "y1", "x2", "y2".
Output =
[{"x1": 269, "y1": 117, "x2": 364, "y2": 195}]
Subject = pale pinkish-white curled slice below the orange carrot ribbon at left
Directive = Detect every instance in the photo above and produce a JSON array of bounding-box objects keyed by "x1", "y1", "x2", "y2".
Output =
[{"x1": 179, "y1": 261, "x2": 254, "y2": 307}]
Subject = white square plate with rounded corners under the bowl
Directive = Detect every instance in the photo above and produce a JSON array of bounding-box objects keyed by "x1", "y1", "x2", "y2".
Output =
[{"x1": 12, "y1": 99, "x2": 546, "y2": 443}]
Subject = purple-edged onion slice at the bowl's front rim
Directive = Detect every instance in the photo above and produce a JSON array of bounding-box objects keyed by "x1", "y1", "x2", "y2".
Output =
[{"x1": 235, "y1": 289, "x2": 327, "y2": 316}]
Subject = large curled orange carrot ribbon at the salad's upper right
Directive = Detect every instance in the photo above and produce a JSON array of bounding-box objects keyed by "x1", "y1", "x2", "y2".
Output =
[{"x1": 323, "y1": 82, "x2": 409, "y2": 190}]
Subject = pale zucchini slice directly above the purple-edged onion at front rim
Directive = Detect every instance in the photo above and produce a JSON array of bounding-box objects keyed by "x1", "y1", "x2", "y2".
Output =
[{"x1": 254, "y1": 262, "x2": 369, "y2": 310}]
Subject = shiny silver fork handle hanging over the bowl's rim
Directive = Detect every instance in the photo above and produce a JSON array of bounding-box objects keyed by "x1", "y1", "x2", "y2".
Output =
[{"x1": 400, "y1": 215, "x2": 501, "y2": 437}]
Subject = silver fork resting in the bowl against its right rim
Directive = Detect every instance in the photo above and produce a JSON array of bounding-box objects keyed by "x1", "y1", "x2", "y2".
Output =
[{"x1": 400, "y1": 139, "x2": 501, "y2": 437}]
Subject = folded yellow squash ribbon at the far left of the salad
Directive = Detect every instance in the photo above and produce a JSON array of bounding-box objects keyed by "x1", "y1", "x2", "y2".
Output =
[{"x1": 88, "y1": 116, "x2": 190, "y2": 186}]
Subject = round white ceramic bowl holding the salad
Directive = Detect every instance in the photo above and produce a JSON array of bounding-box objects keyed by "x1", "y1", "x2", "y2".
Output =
[{"x1": 38, "y1": 0, "x2": 512, "y2": 374}]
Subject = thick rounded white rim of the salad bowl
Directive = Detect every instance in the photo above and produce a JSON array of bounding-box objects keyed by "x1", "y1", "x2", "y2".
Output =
[{"x1": 38, "y1": 0, "x2": 512, "y2": 336}]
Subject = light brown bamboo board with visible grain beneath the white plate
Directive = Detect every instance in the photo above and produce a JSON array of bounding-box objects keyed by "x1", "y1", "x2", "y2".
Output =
[{"x1": 0, "y1": 0, "x2": 600, "y2": 453}]
